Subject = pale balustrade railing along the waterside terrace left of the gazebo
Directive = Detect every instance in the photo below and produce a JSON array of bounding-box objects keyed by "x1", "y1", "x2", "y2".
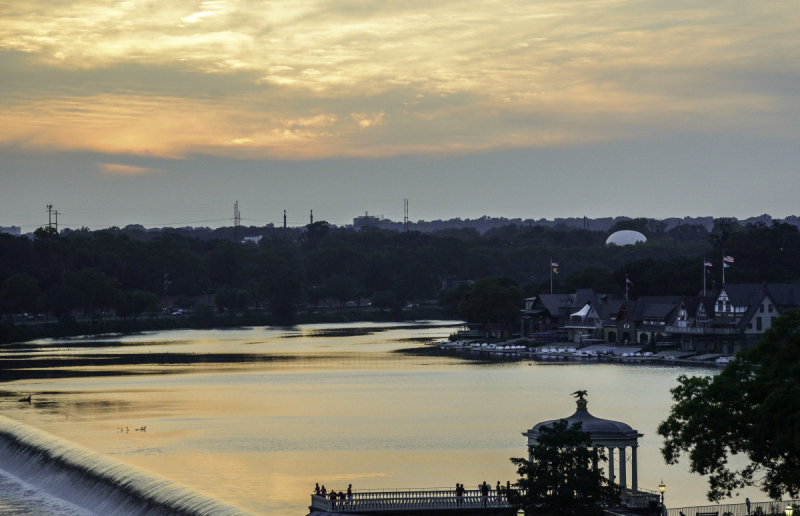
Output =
[{"x1": 311, "y1": 489, "x2": 511, "y2": 513}]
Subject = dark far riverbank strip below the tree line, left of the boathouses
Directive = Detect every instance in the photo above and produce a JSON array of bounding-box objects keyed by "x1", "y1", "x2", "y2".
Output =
[{"x1": 0, "y1": 306, "x2": 449, "y2": 346}]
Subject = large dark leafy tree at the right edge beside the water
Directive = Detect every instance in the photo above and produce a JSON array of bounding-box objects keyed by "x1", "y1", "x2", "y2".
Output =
[{"x1": 658, "y1": 310, "x2": 800, "y2": 501}]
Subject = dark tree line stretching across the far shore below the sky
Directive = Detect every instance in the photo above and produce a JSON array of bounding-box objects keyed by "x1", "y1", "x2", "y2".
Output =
[{"x1": 0, "y1": 219, "x2": 800, "y2": 324}]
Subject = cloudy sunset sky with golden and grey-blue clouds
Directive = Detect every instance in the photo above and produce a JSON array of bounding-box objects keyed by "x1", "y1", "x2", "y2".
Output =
[{"x1": 0, "y1": 0, "x2": 800, "y2": 231}]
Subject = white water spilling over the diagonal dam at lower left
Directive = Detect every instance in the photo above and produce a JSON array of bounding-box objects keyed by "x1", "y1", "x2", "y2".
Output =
[{"x1": 0, "y1": 416, "x2": 253, "y2": 516}]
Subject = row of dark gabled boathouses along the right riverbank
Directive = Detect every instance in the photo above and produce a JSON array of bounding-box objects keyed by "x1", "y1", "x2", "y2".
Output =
[{"x1": 520, "y1": 283, "x2": 800, "y2": 354}]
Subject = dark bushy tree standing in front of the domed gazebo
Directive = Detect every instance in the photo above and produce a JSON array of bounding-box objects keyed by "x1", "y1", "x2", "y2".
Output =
[{"x1": 508, "y1": 419, "x2": 620, "y2": 516}]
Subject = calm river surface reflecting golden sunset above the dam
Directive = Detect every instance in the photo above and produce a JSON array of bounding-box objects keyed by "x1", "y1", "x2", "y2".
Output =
[{"x1": 0, "y1": 322, "x2": 764, "y2": 516}]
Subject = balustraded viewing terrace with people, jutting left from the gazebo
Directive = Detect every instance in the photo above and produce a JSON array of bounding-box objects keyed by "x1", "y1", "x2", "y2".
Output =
[{"x1": 309, "y1": 489, "x2": 517, "y2": 516}]
